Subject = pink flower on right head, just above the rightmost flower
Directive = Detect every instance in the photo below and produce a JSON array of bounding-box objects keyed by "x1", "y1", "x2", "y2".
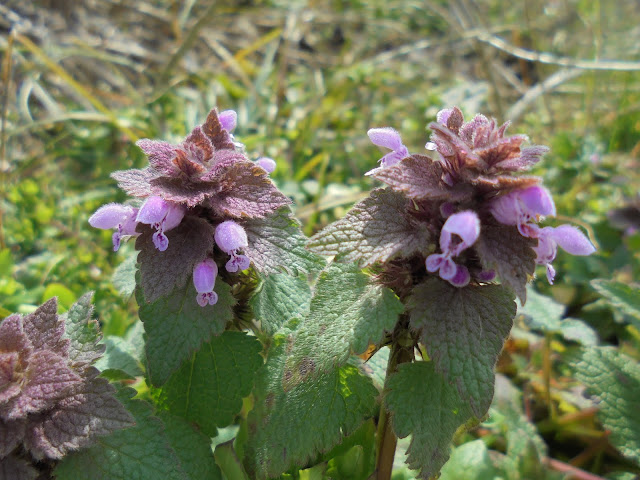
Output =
[{"x1": 490, "y1": 185, "x2": 556, "y2": 238}]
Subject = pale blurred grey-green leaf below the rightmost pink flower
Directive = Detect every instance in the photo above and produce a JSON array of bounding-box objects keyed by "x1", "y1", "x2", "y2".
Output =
[{"x1": 518, "y1": 287, "x2": 598, "y2": 345}]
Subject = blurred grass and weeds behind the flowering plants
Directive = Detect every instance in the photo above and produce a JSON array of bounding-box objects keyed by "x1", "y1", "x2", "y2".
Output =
[{"x1": 0, "y1": 0, "x2": 640, "y2": 478}]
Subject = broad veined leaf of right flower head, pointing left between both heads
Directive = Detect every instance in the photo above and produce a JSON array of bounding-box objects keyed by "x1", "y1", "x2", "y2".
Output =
[{"x1": 309, "y1": 189, "x2": 430, "y2": 267}]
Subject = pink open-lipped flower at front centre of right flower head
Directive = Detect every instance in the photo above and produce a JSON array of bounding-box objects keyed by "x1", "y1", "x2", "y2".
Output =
[{"x1": 426, "y1": 210, "x2": 480, "y2": 287}]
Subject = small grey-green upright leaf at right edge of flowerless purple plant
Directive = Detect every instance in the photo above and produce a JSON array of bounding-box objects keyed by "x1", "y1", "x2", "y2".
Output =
[{"x1": 61, "y1": 293, "x2": 105, "y2": 366}]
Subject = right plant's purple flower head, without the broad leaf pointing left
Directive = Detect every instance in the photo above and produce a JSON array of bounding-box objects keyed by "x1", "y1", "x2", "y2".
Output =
[{"x1": 368, "y1": 107, "x2": 595, "y2": 298}]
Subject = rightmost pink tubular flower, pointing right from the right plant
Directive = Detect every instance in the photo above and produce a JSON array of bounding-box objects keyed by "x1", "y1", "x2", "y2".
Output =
[{"x1": 533, "y1": 225, "x2": 596, "y2": 285}]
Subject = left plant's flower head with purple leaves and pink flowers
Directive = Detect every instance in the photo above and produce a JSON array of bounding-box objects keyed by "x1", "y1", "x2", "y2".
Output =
[{"x1": 89, "y1": 110, "x2": 290, "y2": 306}]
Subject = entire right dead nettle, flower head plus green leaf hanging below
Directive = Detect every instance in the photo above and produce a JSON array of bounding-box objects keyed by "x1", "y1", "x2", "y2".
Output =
[{"x1": 309, "y1": 107, "x2": 595, "y2": 478}]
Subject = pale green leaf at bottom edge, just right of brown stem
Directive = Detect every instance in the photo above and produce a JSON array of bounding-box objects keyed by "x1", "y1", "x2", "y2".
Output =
[{"x1": 440, "y1": 440, "x2": 507, "y2": 480}]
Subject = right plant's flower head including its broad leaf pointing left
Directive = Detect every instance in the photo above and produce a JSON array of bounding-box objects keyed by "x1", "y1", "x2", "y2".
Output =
[{"x1": 309, "y1": 107, "x2": 595, "y2": 302}]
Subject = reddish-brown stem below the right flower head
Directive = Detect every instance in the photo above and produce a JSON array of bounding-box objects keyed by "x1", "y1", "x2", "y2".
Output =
[{"x1": 374, "y1": 339, "x2": 413, "y2": 480}]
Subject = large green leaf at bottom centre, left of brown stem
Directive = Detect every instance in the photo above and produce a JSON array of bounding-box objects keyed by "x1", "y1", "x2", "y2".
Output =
[{"x1": 245, "y1": 329, "x2": 378, "y2": 479}]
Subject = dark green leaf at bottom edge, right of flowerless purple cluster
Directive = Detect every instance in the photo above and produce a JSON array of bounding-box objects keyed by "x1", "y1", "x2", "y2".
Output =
[{"x1": 54, "y1": 388, "x2": 188, "y2": 480}]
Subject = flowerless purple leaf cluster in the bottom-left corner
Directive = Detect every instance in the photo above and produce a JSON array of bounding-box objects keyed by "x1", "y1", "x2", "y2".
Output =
[{"x1": 0, "y1": 298, "x2": 133, "y2": 478}]
